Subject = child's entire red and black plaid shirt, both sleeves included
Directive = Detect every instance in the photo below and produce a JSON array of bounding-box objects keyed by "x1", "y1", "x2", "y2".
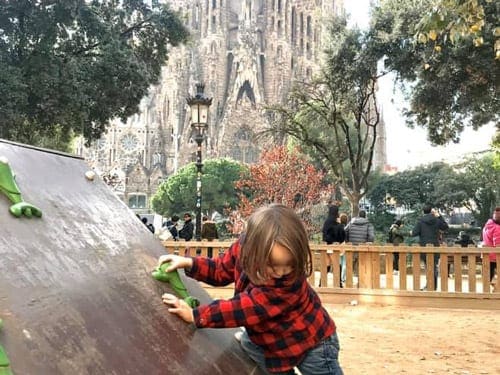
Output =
[{"x1": 186, "y1": 242, "x2": 335, "y2": 372}]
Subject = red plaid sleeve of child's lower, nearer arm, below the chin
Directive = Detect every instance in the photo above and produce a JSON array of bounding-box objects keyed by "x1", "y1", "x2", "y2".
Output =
[{"x1": 193, "y1": 287, "x2": 299, "y2": 328}]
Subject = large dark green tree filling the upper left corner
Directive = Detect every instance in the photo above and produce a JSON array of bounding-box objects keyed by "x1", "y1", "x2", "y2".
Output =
[{"x1": 0, "y1": 0, "x2": 188, "y2": 150}]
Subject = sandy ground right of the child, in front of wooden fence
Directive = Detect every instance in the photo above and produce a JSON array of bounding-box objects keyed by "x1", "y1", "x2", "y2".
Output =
[{"x1": 326, "y1": 304, "x2": 500, "y2": 375}]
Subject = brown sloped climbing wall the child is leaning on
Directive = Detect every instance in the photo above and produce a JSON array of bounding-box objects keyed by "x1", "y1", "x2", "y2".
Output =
[{"x1": 0, "y1": 140, "x2": 260, "y2": 375}]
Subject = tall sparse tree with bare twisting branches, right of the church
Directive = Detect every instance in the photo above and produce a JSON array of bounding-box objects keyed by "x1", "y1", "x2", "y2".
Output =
[{"x1": 270, "y1": 18, "x2": 381, "y2": 215}]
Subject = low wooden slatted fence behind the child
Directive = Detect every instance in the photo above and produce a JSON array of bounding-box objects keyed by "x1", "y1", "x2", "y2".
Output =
[{"x1": 163, "y1": 241, "x2": 500, "y2": 309}]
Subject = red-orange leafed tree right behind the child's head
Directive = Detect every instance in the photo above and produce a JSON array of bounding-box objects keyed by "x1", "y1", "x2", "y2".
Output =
[{"x1": 236, "y1": 146, "x2": 331, "y2": 231}]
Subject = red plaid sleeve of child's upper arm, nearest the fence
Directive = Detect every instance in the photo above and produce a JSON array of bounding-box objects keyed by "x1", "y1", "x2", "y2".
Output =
[{"x1": 185, "y1": 242, "x2": 240, "y2": 286}]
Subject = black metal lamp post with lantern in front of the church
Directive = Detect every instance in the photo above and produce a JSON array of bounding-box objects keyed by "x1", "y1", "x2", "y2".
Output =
[{"x1": 187, "y1": 83, "x2": 212, "y2": 241}]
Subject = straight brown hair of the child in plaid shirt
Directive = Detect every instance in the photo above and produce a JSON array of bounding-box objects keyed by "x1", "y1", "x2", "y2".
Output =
[{"x1": 240, "y1": 204, "x2": 312, "y2": 284}]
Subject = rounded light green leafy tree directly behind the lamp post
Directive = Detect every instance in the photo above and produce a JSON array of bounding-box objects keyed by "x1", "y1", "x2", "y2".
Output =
[{"x1": 151, "y1": 159, "x2": 246, "y2": 216}]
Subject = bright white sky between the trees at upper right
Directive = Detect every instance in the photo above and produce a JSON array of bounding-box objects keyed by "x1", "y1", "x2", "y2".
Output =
[{"x1": 344, "y1": 0, "x2": 495, "y2": 171}]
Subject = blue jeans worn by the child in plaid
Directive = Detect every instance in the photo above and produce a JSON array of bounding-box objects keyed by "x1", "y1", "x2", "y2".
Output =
[{"x1": 240, "y1": 331, "x2": 344, "y2": 375}]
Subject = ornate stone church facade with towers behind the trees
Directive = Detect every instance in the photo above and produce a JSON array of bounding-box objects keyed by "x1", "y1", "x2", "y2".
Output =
[{"x1": 77, "y1": 0, "x2": 386, "y2": 213}]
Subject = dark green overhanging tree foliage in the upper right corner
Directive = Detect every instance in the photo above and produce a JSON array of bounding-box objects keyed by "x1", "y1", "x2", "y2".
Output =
[{"x1": 371, "y1": 0, "x2": 500, "y2": 144}]
